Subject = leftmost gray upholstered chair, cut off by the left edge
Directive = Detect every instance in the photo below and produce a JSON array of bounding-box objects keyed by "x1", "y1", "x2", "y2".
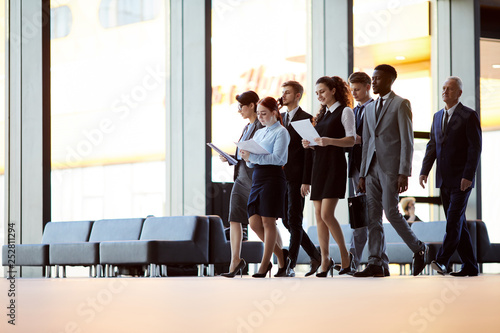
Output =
[{"x1": 2, "y1": 221, "x2": 93, "y2": 277}]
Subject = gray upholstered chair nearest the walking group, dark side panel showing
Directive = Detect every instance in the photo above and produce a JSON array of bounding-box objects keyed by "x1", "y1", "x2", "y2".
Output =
[{"x1": 99, "y1": 216, "x2": 209, "y2": 277}]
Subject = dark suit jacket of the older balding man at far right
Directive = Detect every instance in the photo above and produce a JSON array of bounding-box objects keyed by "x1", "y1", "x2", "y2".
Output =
[{"x1": 420, "y1": 103, "x2": 482, "y2": 188}]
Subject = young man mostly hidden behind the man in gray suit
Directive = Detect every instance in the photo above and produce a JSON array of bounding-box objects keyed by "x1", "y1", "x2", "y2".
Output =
[{"x1": 348, "y1": 72, "x2": 373, "y2": 267}]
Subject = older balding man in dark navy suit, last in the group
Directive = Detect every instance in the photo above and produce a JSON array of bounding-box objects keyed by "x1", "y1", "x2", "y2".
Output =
[{"x1": 419, "y1": 76, "x2": 482, "y2": 276}]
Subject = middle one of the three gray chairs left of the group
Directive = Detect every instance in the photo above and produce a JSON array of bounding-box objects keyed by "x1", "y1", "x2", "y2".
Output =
[{"x1": 49, "y1": 218, "x2": 144, "y2": 277}]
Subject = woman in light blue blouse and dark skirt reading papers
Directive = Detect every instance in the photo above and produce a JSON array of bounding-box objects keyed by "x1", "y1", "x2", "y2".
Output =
[{"x1": 240, "y1": 97, "x2": 290, "y2": 278}]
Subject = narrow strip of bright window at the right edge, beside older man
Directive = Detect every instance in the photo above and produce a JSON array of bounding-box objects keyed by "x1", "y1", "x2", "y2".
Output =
[{"x1": 480, "y1": 39, "x2": 500, "y2": 243}]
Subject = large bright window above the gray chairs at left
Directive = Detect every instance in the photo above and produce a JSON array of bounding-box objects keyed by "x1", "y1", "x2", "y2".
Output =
[{"x1": 51, "y1": 0, "x2": 168, "y2": 226}]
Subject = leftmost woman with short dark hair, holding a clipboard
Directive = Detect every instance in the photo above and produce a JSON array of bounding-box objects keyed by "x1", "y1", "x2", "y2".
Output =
[{"x1": 220, "y1": 90, "x2": 263, "y2": 278}]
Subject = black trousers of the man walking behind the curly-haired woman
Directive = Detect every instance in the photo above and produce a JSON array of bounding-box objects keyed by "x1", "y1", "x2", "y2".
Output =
[{"x1": 283, "y1": 181, "x2": 321, "y2": 268}]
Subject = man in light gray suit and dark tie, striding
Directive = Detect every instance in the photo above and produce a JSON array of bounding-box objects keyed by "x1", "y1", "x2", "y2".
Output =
[{"x1": 354, "y1": 65, "x2": 427, "y2": 277}]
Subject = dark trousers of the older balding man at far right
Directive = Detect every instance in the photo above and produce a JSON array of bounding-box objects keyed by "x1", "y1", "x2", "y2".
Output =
[{"x1": 436, "y1": 187, "x2": 478, "y2": 270}]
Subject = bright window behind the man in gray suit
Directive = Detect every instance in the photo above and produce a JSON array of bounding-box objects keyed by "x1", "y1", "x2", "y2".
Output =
[{"x1": 353, "y1": 0, "x2": 437, "y2": 221}]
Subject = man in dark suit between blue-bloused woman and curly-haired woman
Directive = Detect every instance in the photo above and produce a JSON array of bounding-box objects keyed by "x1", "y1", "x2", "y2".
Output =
[{"x1": 281, "y1": 81, "x2": 321, "y2": 276}]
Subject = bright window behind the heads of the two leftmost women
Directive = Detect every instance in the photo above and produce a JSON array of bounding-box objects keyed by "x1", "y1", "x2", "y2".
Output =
[{"x1": 212, "y1": 0, "x2": 312, "y2": 182}]
